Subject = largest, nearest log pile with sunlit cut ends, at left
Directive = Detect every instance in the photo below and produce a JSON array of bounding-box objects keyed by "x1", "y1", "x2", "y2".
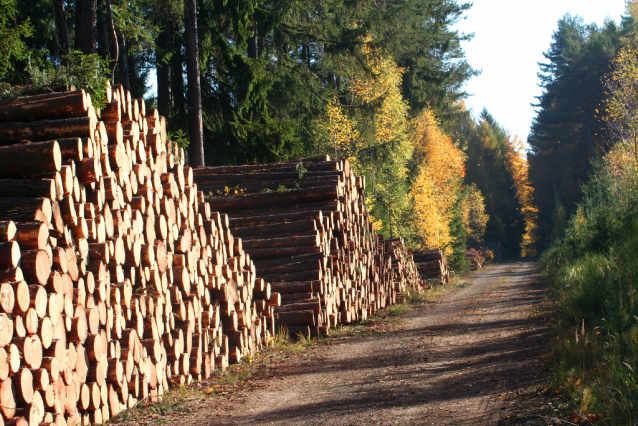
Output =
[{"x1": 0, "y1": 86, "x2": 276, "y2": 425}]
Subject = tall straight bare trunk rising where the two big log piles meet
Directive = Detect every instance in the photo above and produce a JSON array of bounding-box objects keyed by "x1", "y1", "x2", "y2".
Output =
[{"x1": 184, "y1": 0, "x2": 204, "y2": 167}]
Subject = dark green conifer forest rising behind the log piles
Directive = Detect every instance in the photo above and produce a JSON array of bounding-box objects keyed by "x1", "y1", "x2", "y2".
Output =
[{"x1": 0, "y1": 0, "x2": 474, "y2": 169}]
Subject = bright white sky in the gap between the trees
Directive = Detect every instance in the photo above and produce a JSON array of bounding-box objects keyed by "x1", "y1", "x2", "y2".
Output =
[{"x1": 456, "y1": 0, "x2": 625, "y2": 141}]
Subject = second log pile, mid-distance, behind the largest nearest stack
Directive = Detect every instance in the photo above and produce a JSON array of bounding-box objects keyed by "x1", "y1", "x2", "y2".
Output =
[{"x1": 194, "y1": 156, "x2": 417, "y2": 335}]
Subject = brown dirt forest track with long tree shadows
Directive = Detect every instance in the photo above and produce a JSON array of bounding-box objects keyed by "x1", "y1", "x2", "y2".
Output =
[{"x1": 120, "y1": 261, "x2": 573, "y2": 426}]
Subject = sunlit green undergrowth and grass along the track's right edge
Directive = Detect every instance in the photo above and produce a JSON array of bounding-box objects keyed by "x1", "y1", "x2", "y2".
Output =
[{"x1": 542, "y1": 145, "x2": 638, "y2": 425}]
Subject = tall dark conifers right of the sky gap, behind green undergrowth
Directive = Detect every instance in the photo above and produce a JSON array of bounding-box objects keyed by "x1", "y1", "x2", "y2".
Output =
[{"x1": 528, "y1": 15, "x2": 626, "y2": 245}]
